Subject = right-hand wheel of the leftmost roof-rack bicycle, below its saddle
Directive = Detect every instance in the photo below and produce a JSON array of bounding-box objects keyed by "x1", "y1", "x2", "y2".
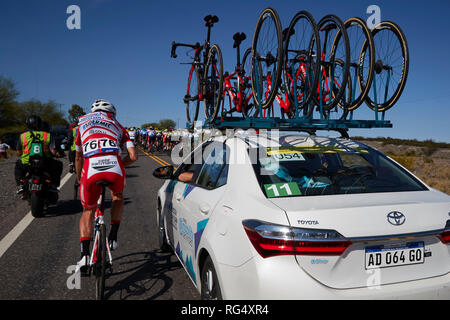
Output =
[{"x1": 203, "y1": 44, "x2": 223, "y2": 123}]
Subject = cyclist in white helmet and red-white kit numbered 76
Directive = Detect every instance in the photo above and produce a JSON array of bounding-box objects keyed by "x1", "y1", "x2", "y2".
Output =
[{"x1": 75, "y1": 100, "x2": 138, "y2": 274}]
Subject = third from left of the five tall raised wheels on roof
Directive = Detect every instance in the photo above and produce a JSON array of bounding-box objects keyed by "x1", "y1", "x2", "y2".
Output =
[{"x1": 309, "y1": 14, "x2": 350, "y2": 115}]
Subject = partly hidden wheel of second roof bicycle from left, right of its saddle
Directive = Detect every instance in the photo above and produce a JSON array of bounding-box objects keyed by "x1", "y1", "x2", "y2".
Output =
[{"x1": 241, "y1": 48, "x2": 258, "y2": 118}]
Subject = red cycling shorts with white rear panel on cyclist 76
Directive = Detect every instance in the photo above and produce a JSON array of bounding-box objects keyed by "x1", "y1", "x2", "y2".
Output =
[{"x1": 80, "y1": 154, "x2": 125, "y2": 209}]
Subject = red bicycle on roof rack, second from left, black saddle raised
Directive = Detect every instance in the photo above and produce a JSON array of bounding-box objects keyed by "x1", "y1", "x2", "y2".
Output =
[{"x1": 222, "y1": 32, "x2": 258, "y2": 119}]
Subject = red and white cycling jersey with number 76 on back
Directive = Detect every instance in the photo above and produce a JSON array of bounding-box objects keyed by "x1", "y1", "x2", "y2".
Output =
[{"x1": 75, "y1": 112, "x2": 134, "y2": 158}]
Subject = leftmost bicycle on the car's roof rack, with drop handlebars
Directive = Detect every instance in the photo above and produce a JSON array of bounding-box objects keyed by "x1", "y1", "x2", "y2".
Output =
[{"x1": 170, "y1": 15, "x2": 223, "y2": 129}]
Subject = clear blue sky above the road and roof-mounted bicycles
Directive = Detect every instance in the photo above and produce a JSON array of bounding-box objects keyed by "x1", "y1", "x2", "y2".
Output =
[{"x1": 0, "y1": 0, "x2": 450, "y2": 142}]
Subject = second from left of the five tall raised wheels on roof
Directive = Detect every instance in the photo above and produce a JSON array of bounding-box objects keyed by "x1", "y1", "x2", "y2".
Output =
[{"x1": 283, "y1": 11, "x2": 321, "y2": 118}]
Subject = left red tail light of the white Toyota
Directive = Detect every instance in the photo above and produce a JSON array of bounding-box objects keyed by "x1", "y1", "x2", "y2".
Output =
[{"x1": 242, "y1": 220, "x2": 351, "y2": 258}]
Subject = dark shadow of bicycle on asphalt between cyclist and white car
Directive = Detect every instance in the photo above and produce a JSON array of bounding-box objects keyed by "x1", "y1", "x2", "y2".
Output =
[{"x1": 105, "y1": 250, "x2": 182, "y2": 300}]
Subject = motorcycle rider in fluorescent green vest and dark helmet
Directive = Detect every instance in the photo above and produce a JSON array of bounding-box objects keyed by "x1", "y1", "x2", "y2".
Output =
[{"x1": 14, "y1": 115, "x2": 62, "y2": 195}]
